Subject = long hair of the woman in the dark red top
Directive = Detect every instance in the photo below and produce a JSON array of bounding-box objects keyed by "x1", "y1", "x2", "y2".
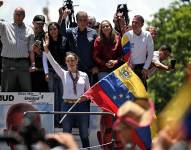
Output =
[{"x1": 99, "y1": 20, "x2": 115, "y2": 44}]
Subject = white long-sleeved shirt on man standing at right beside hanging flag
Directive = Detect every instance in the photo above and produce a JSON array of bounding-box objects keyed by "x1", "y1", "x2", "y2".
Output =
[{"x1": 123, "y1": 30, "x2": 154, "y2": 69}]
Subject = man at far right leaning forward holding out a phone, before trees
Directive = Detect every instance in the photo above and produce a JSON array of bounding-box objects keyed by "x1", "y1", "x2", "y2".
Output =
[{"x1": 148, "y1": 45, "x2": 175, "y2": 77}]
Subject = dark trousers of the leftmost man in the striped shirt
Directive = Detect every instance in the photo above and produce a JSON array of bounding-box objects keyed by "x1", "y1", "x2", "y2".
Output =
[{"x1": 1, "y1": 57, "x2": 32, "y2": 92}]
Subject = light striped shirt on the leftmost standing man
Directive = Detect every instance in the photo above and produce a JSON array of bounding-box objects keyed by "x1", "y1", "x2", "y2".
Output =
[{"x1": 0, "y1": 21, "x2": 34, "y2": 58}]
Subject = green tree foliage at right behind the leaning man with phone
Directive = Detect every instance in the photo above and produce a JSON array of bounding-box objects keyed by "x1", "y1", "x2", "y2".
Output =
[{"x1": 148, "y1": 1, "x2": 191, "y2": 111}]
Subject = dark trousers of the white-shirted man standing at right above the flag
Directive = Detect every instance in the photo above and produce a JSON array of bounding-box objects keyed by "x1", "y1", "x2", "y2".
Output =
[{"x1": 133, "y1": 64, "x2": 147, "y2": 90}]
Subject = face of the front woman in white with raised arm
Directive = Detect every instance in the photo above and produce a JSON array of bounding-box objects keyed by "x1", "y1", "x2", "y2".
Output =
[{"x1": 66, "y1": 55, "x2": 78, "y2": 71}]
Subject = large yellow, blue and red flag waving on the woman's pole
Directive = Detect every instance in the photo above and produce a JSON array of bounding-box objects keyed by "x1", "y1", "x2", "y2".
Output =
[{"x1": 83, "y1": 63, "x2": 147, "y2": 114}]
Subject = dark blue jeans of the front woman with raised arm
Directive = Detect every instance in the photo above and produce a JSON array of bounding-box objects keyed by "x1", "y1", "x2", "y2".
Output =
[{"x1": 62, "y1": 101, "x2": 90, "y2": 148}]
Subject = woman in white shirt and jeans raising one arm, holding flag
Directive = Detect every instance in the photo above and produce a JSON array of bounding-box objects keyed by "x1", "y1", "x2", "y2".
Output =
[{"x1": 44, "y1": 35, "x2": 90, "y2": 147}]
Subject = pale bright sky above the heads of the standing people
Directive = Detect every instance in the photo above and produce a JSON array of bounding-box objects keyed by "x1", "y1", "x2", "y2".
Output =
[{"x1": 0, "y1": 0, "x2": 174, "y2": 25}]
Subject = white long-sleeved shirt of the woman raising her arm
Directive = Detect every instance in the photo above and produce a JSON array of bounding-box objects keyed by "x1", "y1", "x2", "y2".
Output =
[{"x1": 43, "y1": 52, "x2": 90, "y2": 99}]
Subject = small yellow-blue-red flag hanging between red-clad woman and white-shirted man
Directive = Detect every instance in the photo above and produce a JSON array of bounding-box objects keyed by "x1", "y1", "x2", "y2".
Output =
[{"x1": 121, "y1": 34, "x2": 131, "y2": 62}]
